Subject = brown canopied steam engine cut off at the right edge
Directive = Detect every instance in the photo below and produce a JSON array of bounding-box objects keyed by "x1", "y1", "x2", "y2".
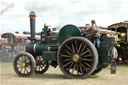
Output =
[{"x1": 108, "y1": 21, "x2": 128, "y2": 64}]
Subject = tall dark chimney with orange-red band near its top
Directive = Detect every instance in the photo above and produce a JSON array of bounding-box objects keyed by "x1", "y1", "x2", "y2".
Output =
[{"x1": 29, "y1": 11, "x2": 36, "y2": 42}]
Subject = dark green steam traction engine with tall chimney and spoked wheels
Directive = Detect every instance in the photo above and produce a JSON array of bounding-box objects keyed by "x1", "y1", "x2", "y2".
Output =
[{"x1": 13, "y1": 11, "x2": 115, "y2": 78}]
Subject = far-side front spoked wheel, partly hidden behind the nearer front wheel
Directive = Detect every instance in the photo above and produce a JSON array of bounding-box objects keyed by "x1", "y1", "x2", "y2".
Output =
[{"x1": 35, "y1": 56, "x2": 49, "y2": 74}]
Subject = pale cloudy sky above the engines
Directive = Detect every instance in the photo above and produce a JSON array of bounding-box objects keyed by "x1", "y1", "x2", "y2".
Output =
[{"x1": 0, "y1": 0, "x2": 128, "y2": 33}]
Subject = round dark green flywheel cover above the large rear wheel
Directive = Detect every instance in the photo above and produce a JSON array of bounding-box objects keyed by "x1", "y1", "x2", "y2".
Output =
[{"x1": 58, "y1": 25, "x2": 81, "y2": 45}]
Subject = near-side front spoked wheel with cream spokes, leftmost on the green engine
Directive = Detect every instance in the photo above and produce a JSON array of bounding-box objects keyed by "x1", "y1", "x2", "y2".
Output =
[{"x1": 13, "y1": 52, "x2": 36, "y2": 77}]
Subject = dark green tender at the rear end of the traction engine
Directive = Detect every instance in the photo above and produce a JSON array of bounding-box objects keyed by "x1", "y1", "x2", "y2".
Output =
[{"x1": 99, "y1": 37, "x2": 116, "y2": 65}]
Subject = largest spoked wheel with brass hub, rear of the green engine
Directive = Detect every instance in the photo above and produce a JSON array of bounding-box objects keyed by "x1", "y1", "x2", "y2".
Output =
[{"x1": 57, "y1": 37, "x2": 98, "y2": 78}]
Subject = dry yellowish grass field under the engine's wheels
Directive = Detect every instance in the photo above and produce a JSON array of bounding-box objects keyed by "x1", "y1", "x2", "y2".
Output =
[{"x1": 0, "y1": 63, "x2": 128, "y2": 85}]
